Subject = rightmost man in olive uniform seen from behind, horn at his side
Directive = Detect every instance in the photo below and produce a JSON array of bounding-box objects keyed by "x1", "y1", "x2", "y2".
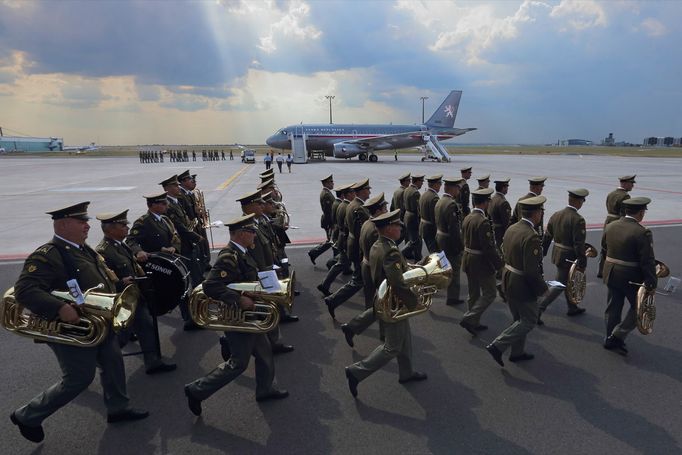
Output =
[{"x1": 601, "y1": 197, "x2": 658, "y2": 355}]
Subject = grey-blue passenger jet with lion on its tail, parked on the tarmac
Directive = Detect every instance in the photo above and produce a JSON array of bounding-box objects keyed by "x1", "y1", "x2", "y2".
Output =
[{"x1": 265, "y1": 90, "x2": 476, "y2": 162}]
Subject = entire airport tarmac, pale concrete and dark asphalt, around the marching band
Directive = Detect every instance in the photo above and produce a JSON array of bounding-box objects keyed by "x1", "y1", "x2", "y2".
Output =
[{"x1": 0, "y1": 152, "x2": 682, "y2": 455}]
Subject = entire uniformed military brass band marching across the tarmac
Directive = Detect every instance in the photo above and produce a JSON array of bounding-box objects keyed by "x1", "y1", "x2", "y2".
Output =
[{"x1": 2, "y1": 166, "x2": 669, "y2": 442}]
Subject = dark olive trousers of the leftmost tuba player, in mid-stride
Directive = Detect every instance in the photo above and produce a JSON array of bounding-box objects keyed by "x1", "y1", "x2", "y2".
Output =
[{"x1": 16, "y1": 326, "x2": 129, "y2": 427}]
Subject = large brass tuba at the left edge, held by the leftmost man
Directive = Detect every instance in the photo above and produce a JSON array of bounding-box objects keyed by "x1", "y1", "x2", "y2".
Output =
[{"x1": 0, "y1": 285, "x2": 139, "y2": 348}]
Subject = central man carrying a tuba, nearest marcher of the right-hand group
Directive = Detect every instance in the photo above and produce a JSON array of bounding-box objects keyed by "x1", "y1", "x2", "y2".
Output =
[{"x1": 346, "y1": 210, "x2": 427, "y2": 397}]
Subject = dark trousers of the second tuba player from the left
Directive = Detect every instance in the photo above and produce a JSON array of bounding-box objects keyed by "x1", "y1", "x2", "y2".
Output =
[{"x1": 187, "y1": 332, "x2": 275, "y2": 400}]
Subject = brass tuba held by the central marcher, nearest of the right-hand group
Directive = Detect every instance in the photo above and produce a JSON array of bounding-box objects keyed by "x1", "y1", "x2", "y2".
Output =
[{"x1": 374, "y1": 253, "x2": 452, "y2": 322}]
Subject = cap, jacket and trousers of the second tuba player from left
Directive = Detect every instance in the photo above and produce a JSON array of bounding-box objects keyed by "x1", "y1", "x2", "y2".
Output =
[{"x1": 185, "y1": 215, "x2": 283, "y2": 401}]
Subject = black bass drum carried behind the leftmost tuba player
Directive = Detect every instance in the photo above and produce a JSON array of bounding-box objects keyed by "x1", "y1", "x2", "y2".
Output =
[{"x1": 144, "y1": 253, "x2": 192, "y2": 316}]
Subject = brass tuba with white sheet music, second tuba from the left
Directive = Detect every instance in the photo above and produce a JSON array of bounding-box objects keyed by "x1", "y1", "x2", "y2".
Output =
[{"x1": 189, "y1": 273, "x2": 295, "y2": 333}]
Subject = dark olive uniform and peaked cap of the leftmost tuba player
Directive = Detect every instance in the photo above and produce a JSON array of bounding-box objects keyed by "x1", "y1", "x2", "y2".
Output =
[{"x1": 12, "y1": 202, "x2": 141, "y2": 434}]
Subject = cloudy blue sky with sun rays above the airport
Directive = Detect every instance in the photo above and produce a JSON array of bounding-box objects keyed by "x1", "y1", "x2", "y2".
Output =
[{"x1": 0, "y1": 0, "x2": 682, "y2": 145}]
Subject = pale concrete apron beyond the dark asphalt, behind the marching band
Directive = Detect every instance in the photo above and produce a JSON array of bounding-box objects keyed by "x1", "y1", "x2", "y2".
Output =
[{"x1": 0, "y1": 155, "x2": 682, "y2": 259}]
